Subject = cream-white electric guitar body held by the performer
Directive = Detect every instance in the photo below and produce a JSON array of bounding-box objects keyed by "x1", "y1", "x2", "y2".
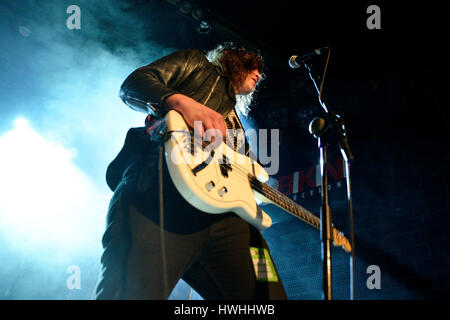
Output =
[{"x1": 164, "y1": 110, "x2": 272, "y2": 230}]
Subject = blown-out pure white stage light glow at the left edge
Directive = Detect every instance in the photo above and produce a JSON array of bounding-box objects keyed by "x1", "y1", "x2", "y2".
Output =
[{"x1": 0, "y1": 118, "x2": 108, "y2": 256}]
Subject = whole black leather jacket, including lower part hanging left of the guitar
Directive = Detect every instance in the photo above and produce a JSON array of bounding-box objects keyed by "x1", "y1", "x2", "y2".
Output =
[{"x1": 106, "y1": 49, "x2": 242, "y2": 191}]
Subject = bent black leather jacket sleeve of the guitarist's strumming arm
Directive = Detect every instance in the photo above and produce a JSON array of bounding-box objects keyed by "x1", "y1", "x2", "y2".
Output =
[{"x1": 119, "y1": 49, "x2": 207, "y2": 116}]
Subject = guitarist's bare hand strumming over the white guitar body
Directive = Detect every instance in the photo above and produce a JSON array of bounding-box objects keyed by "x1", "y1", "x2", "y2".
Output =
[{"x1": 165, "y1": 93, "x2": 226, "y2": 140}]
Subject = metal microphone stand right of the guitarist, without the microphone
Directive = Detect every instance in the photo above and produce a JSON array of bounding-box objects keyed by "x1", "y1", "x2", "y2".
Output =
[{"x1": 303, "y1": 61, "x2": 355, "y2": 300}]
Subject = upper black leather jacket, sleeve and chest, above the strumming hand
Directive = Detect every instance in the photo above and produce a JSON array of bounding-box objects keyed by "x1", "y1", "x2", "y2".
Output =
[{"x1": 120, "y1": 49, "x2": 236, "y2": 116}]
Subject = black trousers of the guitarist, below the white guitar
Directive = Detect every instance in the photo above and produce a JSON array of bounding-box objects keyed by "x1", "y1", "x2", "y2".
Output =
[{"x1": 96, "y1": 158, "x2": 287, "y2": 300}]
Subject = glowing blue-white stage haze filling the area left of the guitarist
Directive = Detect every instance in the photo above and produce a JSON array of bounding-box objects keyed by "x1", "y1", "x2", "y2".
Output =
[{"x1": 0, "y1": 0, "x2": 201, "y2": 299}]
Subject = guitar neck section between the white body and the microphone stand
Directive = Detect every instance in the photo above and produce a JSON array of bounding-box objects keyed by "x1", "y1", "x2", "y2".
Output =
[{"x1": 248, "y1": 175, "x2": 320, "y2": 229}]
